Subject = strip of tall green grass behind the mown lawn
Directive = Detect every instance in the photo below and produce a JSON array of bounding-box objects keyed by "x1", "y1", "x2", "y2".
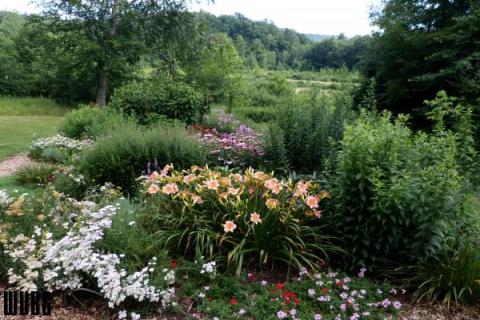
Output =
[{"x1": 0, "y1": 96, "x2": 67, "y2": 116}]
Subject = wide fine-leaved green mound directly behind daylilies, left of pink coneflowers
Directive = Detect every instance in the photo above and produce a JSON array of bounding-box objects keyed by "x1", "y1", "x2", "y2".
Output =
[{"x1": 78, "y1": 125, "x2": 206, "y2": 192}]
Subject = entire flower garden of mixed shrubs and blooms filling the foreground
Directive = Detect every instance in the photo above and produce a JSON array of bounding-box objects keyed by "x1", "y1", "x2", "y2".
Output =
[{"x1": 0, "y1": 73, "x2": 480, "y2": 320}]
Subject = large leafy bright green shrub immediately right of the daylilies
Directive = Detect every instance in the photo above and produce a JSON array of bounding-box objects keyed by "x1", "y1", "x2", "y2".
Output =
[{"x1": 333, "y1": 111, "x2": 463, "y2": 268}]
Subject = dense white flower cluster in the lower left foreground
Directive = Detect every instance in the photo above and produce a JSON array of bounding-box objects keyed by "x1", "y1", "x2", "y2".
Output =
[{"x1": 5, "y1": 201, "x2": 175, "y2": 308}]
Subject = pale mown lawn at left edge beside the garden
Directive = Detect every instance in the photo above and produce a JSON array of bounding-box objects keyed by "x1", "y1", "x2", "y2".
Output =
[{"x1": 0, "y1": 115, "x2": 62, "y2": 161}]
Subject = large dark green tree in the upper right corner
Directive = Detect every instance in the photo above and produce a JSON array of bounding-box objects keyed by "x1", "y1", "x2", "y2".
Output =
[{"x1": 363, "y1": 0, "x2": 480, "y2": 125}]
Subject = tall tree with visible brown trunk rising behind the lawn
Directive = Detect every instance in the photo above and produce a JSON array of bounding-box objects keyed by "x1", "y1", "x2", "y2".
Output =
[{"x1": 43, "y1": 0, "x2": 195, "y2": 106}]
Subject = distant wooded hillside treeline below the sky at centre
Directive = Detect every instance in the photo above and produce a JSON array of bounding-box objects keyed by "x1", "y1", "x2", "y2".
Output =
[{"x1": 197, "y1": 12, "x2": 371, "y2": 71}]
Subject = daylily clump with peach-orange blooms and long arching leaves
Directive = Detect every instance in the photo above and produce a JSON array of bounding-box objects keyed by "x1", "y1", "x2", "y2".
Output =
[{"x1": 137, "y1": 166, "x2": 335, "y2": 275}]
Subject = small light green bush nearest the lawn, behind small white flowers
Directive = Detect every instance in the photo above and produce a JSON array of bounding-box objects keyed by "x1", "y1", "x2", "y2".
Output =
[{"x1": 59, "y1": 105, "x2": 126, "y2": 139}]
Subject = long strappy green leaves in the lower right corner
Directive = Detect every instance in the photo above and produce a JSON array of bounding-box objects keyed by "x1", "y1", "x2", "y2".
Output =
[{"x1": 396, "y1": 193, "x2": 480, "y2": 306}]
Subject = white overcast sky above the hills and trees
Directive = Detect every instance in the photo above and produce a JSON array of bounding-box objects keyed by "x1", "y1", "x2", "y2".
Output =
[{"x1": 0, "y1": 0, "x2": 381, "y2": 36}]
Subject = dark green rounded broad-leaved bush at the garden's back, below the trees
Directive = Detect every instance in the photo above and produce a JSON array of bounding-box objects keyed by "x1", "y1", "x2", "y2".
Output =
[{"x1": 109, "y1": 79, "x2": 208, "y2": 124}]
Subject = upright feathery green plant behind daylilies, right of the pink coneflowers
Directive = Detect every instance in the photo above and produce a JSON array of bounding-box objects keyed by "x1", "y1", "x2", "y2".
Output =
[{"x1": 276, "y1": 91, "x2": 353, "y2": 173}]
